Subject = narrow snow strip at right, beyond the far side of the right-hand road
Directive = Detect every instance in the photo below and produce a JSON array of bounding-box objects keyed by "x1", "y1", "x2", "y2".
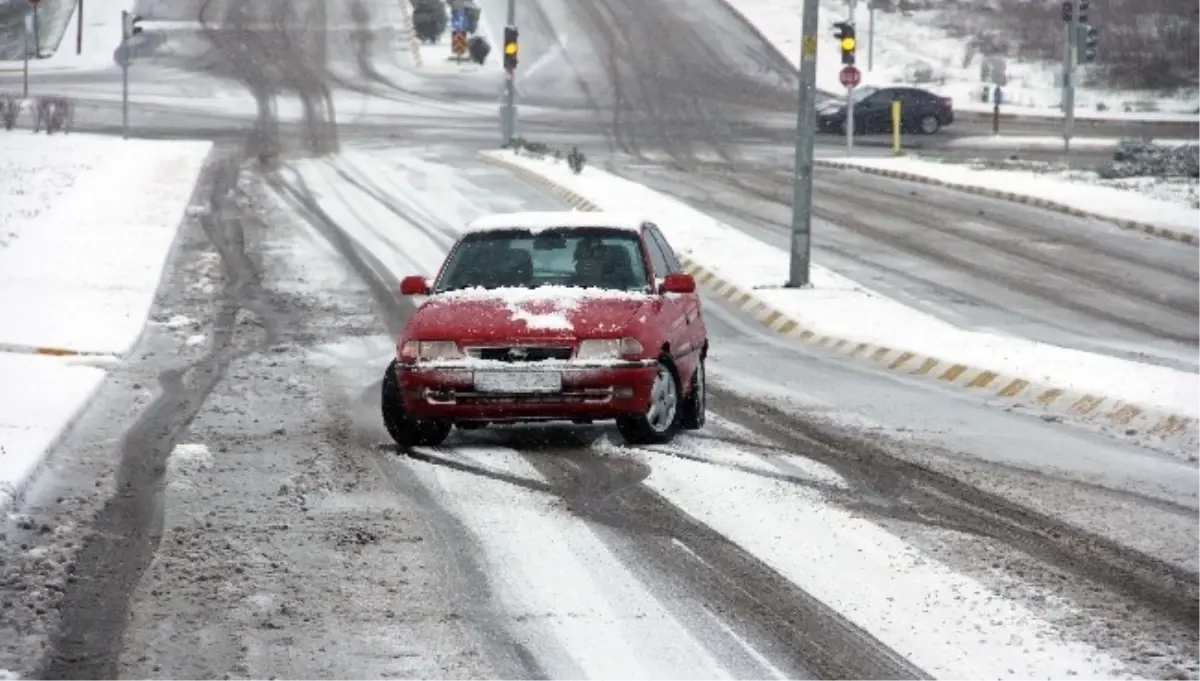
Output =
[{"x1": 829, "y1": 152, "x2": 1200, "y2": 237}]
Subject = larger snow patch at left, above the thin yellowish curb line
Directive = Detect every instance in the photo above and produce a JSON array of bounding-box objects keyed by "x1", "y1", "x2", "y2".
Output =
[{"x1": 0, "y1": 134, "x2": 211, "y2": 355}]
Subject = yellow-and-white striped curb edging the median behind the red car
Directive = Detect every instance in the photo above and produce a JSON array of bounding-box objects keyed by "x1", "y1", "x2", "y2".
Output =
[{"x1": 479, "y1": 153, "x2": 1200, "y2": 441}]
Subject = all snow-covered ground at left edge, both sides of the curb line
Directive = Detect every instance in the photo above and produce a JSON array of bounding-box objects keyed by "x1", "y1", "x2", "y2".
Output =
[{"x1": 0, "y1": 134, "x2": 211, "y2": 506}]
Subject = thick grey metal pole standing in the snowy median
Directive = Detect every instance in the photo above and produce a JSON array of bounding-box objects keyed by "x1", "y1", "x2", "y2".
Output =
[{"x1": 787, "y1": 0, "x2": 820, "y2": 288}]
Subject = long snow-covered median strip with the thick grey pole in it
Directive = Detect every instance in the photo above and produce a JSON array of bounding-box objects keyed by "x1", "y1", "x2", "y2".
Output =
[{"x1": 485, "y1": 151, "x2": 1200, "y2": 417}]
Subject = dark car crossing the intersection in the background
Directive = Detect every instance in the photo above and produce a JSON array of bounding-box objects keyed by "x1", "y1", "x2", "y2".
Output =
[{"x1": 817, "y1": 85, "x2": 954, "y2": 134}]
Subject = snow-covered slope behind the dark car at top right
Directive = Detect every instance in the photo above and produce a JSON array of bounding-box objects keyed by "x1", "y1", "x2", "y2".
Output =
[{"x1": 728, "y1": 0, "x2": 1200, "y2": 121}]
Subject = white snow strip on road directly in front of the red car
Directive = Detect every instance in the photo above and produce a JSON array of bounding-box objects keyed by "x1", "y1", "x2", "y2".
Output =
[{"x1": 396, "y1": 447, "x2": 763, "y2": 681}]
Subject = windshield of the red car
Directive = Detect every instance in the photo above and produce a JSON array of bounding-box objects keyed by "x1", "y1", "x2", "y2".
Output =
[{"x1": 434, "y1": 227, "x2": 649, "y2": 293}]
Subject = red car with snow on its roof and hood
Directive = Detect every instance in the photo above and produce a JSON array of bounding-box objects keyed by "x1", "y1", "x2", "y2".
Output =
[{"x1": 383, "y1": 211, "x2": 708, "y2": 447}]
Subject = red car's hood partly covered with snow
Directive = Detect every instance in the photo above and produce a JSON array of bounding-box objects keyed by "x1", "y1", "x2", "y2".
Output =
[{"x1": 408, "y1": 287, "x2": 654, "y2": 343}]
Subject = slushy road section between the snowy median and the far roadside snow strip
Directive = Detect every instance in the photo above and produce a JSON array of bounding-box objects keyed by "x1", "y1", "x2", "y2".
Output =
[{"x1": 620, "y1": 161, "x2": 1200, "y2": 370}]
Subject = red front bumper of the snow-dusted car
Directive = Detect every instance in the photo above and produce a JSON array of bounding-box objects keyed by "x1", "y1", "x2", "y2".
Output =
[{"x1": 397, "y1": 360, "x2": 658, "y2": 422}]
